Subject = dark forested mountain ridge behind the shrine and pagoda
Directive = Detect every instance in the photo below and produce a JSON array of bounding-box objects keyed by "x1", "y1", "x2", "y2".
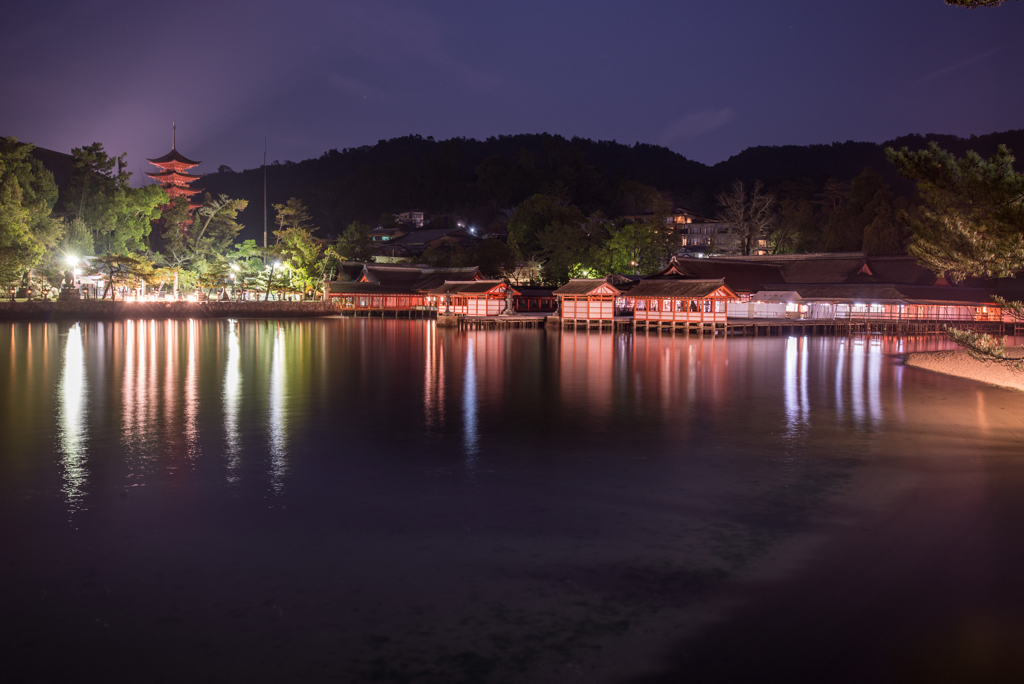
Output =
[{"x1": 203, "y1": 130, "x2": 1024, "y2": 244}]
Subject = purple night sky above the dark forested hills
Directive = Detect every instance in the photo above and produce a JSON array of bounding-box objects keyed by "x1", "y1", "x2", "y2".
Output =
[{"x1": 0, "y1": 0, "x2": 1024, "y2": 178}]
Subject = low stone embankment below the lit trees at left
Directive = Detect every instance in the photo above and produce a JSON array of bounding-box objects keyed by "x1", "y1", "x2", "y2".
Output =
[{"x1": 0, "y1": 300, "x2": 338, "y2": 322}]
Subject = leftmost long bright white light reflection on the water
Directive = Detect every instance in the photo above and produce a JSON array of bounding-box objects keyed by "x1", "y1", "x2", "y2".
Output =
[{"x1": 56, "y1": 324, "x2": 89, "y2": 514}]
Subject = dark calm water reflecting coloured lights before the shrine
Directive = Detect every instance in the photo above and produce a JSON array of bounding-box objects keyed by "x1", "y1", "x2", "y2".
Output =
[{"x1": 0, "y1": 319, "x2": 1024, "y2": 682}]
